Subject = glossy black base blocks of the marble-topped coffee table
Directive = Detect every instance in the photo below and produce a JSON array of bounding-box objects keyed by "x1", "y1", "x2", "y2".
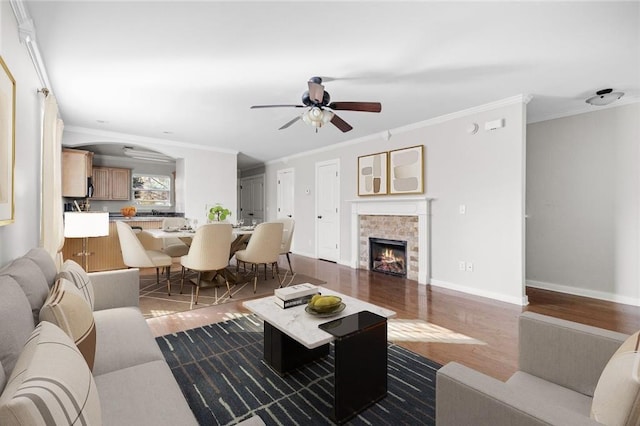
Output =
[{"x1": 264, "y1": 312, "x2": 387, "y2": 423}]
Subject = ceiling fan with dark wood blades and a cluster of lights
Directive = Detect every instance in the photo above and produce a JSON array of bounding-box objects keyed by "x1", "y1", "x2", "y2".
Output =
[{"x1": 251, "y1": 77, "x2": 382, "y2": 132}]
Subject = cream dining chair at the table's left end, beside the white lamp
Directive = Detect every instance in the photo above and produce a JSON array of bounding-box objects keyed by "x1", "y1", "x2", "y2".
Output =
[{"x1": 116, "y1": 221, "x2": 173, "y2": 296}]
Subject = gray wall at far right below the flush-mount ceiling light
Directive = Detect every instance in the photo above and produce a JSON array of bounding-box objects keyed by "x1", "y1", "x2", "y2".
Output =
[{"x1": 526, "y1": 103, "x2": 640, "y2": 305}]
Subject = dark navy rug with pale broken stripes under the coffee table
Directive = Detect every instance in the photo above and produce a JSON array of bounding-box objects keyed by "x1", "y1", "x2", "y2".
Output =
[{"x1": 156, "y1": 314, "x2": 440, "y2": 426}]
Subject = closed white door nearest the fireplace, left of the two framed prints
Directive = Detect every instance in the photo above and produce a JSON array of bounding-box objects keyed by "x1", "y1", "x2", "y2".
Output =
[{"x1": 316, "y1": 160, "x2": 340, "y2": 262}]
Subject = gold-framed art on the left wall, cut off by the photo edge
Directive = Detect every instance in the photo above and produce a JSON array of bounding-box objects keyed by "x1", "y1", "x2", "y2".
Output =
[{"x1": 0, "y1": 57, "x2": 16, "y2": 226}]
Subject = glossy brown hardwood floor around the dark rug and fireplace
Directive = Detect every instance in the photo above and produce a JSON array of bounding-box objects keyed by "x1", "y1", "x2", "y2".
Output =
[{"x1": 147, "y1": 255, "x2": 640, "y2": 380}]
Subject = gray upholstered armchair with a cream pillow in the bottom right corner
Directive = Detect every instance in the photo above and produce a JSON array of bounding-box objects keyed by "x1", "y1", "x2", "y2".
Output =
[{"x1": 436, "y1": 312, "x2": 640, "y2": 426}]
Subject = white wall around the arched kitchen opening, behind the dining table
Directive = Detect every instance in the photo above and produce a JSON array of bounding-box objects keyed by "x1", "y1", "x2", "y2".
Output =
[{"x1": 62, "y1": 127, "x2": 238, "y2": 224}]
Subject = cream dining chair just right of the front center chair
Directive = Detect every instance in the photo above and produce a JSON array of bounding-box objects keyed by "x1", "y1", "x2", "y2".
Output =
[{"x1": 236, "y1": 222, "x2": 284, "y2": 293}]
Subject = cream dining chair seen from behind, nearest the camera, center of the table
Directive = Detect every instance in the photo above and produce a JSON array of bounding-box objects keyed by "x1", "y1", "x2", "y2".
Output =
[{"x1": 180, "y1": 222, "x2": 233, "y2": 305}]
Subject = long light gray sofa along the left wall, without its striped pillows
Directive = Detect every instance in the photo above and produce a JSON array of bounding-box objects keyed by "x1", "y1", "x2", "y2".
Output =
[{"x1": 0, "y1": 249, "x2": 197, "y2": 426}]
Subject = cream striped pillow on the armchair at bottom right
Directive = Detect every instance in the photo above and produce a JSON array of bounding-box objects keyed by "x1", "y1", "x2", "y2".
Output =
[{"x1": 591, "y1": 331, "x2": 640, "y2": 425}]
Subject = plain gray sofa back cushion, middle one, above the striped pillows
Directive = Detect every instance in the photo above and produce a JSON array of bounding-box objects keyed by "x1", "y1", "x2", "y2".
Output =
[{"x1": 1, "y1": 257, "x2": 49, "y2": 323}]
